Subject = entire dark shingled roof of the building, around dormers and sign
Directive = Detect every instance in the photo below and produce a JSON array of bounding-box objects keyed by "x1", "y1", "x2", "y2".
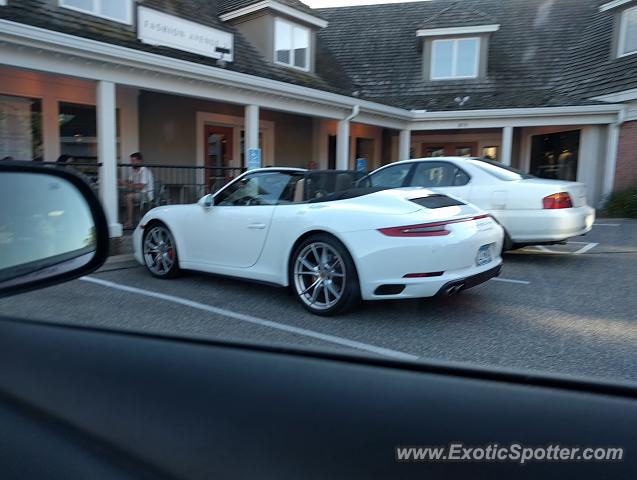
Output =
[{"x1": 0, "y1": 0, "x2": 637, "y2": 111}]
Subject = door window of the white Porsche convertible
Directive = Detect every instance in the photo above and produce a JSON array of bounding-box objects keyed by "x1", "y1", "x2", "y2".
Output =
[{"x1": 215, "y1": 172, "x2": 301, "y2": 207}]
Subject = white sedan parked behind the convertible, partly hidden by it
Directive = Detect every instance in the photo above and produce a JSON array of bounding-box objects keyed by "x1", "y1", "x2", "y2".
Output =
[{"x1": 364, "y1": 157, "x2": 595, "y2": 250}]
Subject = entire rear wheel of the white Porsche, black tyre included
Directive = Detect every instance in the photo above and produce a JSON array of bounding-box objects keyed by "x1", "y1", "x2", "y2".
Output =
[{"x1": 290, "y1": 234, "x2": 360, "y2": 316}]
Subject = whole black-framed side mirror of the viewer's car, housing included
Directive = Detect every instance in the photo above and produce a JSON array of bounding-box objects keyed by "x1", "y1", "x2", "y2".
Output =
[{"x1": 0, "y1": 162, "x2": 109, "y2": 297}]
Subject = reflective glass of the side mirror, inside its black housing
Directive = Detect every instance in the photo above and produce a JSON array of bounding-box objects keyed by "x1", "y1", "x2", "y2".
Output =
[{"x1": 0, "y1": 172, "x2": 97, "y2": 288}]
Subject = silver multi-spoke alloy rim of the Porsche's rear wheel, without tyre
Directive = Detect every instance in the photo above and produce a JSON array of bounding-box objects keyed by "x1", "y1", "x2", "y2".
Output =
[{"x1": 293, "y1": 241, "x2": 348, "y2": 313}]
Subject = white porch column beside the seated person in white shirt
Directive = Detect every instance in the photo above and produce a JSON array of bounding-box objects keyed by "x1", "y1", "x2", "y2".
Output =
[{"x1": 95, "y1": 81, "x2": 122, "y2": 237}]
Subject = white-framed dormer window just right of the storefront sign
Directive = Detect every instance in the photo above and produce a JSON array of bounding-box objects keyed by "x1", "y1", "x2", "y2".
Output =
[{"x1": 274, "y1": 18, "x2": 310, "y2": 70}]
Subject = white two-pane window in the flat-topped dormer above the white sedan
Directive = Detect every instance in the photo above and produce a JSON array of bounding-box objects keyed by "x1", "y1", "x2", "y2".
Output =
[{"x1": 431, "y1": 38, "x2": 480, "y2": 80}]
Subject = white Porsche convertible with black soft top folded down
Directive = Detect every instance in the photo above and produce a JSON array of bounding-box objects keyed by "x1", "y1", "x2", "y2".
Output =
[{"x1": 133, "y1": 168, "x2": 503, "y2": 315}]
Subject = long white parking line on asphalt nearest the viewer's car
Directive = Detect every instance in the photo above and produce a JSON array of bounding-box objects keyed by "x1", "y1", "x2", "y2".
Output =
[{"x1": 80, "y1": 277, "x2": 419, "y2": 360}]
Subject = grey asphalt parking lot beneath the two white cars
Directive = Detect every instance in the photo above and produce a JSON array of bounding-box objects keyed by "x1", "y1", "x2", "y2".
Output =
[{"x1": 0, "y1": 220, "x2": 637, "y2": 381}]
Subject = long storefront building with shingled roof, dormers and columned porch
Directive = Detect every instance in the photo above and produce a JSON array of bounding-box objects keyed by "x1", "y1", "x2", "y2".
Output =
[{"x1": 0, "y1": 0, "x2": 637, "y2": 236}]
